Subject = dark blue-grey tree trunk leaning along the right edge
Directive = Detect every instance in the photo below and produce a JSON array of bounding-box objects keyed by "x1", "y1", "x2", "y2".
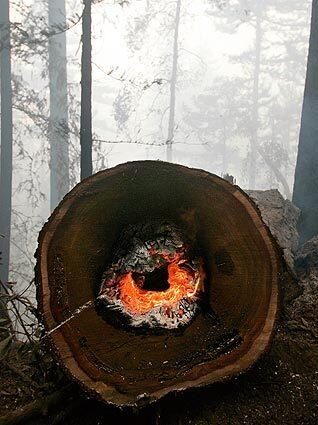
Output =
[{"x1": 293, "y1": 0, "x2": 318, "y2": 243}]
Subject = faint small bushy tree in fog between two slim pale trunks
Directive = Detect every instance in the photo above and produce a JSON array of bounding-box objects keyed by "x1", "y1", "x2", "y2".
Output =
[{"x1": 183, "y1": 77, "x2": 249, "y2": 175}]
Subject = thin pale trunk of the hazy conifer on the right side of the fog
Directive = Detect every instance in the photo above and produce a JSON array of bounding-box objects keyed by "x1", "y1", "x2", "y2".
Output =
[{"x1": 248, "y1": 0, "x2": 263, "y2": 189}]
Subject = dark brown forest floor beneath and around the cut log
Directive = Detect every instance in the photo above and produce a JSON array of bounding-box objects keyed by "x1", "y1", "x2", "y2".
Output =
[{"x1": 0, "y1": 190, "x2": 318, "y2": 425}]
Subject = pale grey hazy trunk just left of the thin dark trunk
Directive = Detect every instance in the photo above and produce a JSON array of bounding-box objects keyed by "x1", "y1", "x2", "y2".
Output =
[{"x1": 48, "y1": 0, "x2": 70, "y2": 211}]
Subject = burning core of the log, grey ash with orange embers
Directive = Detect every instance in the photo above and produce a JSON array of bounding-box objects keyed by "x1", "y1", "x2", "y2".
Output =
[{"x1": 99, "y1": 222, "x2": 205, "y2": 329}]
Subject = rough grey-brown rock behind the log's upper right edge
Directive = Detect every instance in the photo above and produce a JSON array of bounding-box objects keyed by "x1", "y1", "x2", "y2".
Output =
[{"x1": 246, "y1": 189, "x2": 300, "y2": 270}]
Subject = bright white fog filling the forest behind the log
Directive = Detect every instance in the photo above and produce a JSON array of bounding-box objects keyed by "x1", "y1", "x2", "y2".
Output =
[{"x1": 3, "y1": 0, "x2": 311, "y2": 286}]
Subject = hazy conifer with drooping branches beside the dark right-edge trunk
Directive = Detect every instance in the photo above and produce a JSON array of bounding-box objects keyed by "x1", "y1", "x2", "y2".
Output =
[{"x1": 208, "y1": 0, "x2": 306, "y2": 190}]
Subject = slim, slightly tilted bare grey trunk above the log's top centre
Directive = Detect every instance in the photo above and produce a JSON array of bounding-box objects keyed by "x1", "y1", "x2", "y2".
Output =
[{"x1": 167, "y1": 0, "x2": 181, "y2": 162}]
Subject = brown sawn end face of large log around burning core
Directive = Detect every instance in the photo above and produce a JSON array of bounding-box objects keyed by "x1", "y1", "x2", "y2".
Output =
[{"x1": 36, "y1": 161, "x2": 285, "y2": 406}]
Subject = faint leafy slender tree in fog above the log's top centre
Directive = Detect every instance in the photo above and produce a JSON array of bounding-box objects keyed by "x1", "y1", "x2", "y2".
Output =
[{"x1": 114, "y1": 0, "x2": 205, "y2": 156}]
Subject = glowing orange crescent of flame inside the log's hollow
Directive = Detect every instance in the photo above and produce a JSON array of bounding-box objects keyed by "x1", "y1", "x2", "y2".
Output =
[{"x1": 119, "y1": 254, "x2": 203, "y2": 314}]
